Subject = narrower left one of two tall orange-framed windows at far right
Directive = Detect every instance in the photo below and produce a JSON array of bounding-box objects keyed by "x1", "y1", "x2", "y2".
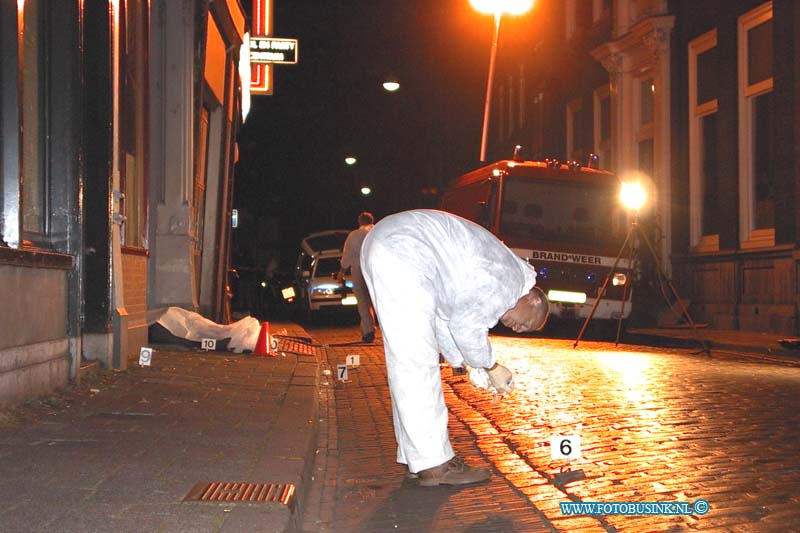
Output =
[{"x1": 689, "y1": 30, "x2": 719, "y2": 252}]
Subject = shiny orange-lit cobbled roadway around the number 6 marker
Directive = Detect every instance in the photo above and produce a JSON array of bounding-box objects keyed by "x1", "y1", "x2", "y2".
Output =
[{"x1": 453, "y1": 337, "x2": 800, "y2": 533}]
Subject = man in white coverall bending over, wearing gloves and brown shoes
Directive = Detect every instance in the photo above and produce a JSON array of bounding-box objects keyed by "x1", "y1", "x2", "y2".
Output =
[{"x1": 361, "y1": 210, "x2": 549, "y2": 486}]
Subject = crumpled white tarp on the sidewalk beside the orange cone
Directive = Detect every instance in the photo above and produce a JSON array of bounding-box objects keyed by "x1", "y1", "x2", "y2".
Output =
[{"x1": 147, "y1": 307, "x2": 261, "y2": 353}]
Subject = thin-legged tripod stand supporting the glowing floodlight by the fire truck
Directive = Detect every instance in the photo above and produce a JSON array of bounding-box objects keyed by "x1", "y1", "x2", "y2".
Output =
[{"x1": 572, "y1": 184, "x2": 711, "y2": 355}]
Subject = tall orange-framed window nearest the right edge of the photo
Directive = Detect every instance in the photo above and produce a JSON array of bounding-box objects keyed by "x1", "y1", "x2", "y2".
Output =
[{"x1": 738, "y1": 2, "x2": 775, "y2": 249}]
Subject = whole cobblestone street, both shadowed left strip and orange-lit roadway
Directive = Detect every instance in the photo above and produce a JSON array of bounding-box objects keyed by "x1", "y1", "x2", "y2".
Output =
[{"x1": 304, "y1": 322, "x2": 800, "y2": 532}]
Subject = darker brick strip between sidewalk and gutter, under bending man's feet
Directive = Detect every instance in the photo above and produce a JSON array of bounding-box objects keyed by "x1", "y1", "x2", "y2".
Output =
[{"x1": 303, "y1": 328, "x2": 556, "y2": 532}]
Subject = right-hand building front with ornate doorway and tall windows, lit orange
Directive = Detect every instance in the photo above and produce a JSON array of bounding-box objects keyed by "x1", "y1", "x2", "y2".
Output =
[{"x1": 492, "y1": 0, "x2": 800, "y2": 335}]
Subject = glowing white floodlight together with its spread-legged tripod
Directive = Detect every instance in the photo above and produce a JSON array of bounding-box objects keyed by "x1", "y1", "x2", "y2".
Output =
[{"x1": 572, "y1": 179, "x2": 710, "y2": 354}]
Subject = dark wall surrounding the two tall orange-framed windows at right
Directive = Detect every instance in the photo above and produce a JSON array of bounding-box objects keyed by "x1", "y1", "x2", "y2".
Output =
[{"x1": 672, "y1": 0, "x2": 800, "y2": 336}]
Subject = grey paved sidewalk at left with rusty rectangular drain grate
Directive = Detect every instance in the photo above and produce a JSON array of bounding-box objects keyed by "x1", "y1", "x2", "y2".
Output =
[{"x1": 0, "y1": 323, "x2": 319, "y2": 532}]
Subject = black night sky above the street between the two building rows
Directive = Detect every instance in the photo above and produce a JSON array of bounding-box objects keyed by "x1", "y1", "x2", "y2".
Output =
[{"x1": 233, "y1": 0, "x2": 532, "y2": 268}]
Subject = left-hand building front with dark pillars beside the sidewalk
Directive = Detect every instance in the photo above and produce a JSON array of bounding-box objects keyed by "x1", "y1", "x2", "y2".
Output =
[{"x1": 0, "y1": 0, "x2": 245, "y2": 402}]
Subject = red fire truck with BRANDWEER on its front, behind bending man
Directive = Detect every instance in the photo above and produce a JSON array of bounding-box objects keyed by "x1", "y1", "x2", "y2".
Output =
[{"x1": 439, "y1": 160, "x2": 633, "y2": 321}]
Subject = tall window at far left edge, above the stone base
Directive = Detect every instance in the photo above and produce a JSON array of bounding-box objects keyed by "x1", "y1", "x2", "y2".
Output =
[{"x1": 0, "y1": 0, "x2": 72, "y2": 252}]
